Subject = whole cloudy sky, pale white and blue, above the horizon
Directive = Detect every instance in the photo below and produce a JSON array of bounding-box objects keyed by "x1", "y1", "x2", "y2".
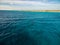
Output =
[{"x1": 0, "y1": 0, "x2": 60, "y2": 10}]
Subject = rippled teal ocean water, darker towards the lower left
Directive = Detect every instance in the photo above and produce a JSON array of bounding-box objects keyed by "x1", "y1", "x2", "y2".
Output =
[{"x1": 0, "y1": 10, "x2": 60, "y2": 45}]
